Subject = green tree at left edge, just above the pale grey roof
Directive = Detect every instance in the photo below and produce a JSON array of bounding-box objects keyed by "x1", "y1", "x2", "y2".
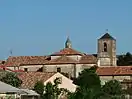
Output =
[{"x1": 0, "y1": 72, "x2": 22, "y2": 87}]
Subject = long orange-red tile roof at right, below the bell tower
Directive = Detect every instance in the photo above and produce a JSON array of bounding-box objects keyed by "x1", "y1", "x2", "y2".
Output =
[{"x1": 97, "y1": 66, "x2": 132, "y2": 76}]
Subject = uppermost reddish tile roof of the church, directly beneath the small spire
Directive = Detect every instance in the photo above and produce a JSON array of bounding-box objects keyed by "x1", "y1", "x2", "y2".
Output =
[{"x1": 51, "y1": 48, "x2": 83, "y2": 56}]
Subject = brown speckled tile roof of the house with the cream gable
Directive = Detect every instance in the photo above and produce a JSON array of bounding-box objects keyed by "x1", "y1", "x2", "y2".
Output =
[{"x1": 18, "y1": 72, "x2": 55, "y2": 89}]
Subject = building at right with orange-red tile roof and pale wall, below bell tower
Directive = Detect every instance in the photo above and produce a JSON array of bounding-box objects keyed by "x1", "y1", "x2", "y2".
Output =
[{"x1": 96, "y1": 66, "x2": 132, "y2": 87}]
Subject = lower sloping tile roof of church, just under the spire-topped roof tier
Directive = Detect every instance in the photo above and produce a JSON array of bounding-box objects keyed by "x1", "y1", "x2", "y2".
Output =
[{"x1": 45, "y1": 56, "x2": 78, "y2": 64}]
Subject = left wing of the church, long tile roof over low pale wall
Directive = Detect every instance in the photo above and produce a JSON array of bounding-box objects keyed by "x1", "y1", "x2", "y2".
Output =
[{"x1": 3, "y1": 56, "x2": 48, "y2": 71}]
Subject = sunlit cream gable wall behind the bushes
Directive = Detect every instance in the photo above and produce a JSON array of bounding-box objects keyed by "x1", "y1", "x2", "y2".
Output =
[{"x1": 44, "y1": 73, "x2": 77, "y2": 92}]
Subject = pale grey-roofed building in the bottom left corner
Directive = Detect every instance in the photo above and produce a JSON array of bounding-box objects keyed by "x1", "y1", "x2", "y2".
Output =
[{"x1": 0, "y1": 81, "x2": 39, "y2": 99}]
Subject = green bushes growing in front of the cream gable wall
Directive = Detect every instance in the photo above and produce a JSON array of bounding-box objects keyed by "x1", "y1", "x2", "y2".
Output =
[{"x1": 34, "y1": 78, "x2": 68, "y2": 99}]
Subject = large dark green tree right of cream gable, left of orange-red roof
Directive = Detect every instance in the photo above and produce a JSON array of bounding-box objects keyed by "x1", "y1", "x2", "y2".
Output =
[{"x1": 74, "y1": 67, "x2": 101, "y2": 88}]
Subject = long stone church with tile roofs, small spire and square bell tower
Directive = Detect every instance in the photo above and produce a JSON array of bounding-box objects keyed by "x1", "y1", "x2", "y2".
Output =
[{"x1": 4, "y1": 31, "x2": 116, "y2": 77}]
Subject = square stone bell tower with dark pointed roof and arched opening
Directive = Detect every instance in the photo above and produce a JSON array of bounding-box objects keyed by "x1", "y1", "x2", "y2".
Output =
[{"x1": 97, "y1": 30, "x2": 116, "y2": 66}]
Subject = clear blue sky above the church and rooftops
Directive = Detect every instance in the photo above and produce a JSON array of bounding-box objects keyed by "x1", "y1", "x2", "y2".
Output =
[{"x1": 0, "y1": 0, "x2": 132, "y2": 59}]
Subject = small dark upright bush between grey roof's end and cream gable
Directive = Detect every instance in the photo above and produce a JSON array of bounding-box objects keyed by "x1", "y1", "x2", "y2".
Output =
[{"x1": 34, "y1": 81, "x2": 44, "y2": 97}]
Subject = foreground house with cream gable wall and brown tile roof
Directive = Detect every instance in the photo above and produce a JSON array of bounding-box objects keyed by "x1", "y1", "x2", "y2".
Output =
[{"x1": 18, "y1": 72, "x2": 77, "y2": 92}]
